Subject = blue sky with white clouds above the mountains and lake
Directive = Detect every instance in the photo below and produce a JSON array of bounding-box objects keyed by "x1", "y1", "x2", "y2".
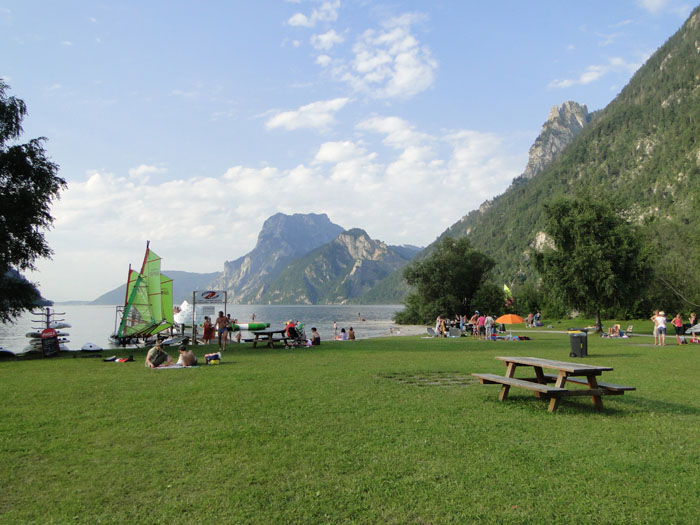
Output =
[{"x1": 0, "y1": 0, "x2": 694, "y2": 301}]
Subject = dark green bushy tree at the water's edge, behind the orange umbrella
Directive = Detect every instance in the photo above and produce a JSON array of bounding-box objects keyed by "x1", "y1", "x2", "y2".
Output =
[{"x1": 396, "y1": 237, "x2": 494, "y2": 324}]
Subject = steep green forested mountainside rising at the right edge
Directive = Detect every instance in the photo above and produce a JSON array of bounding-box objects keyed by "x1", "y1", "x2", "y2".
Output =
[{"x1": 443, "y1": 8, "x2": 700, "y2": 304}]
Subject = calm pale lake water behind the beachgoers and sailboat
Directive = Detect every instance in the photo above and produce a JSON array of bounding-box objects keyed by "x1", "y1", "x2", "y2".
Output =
[{"x1": 0, "y1": 304, "x2": 403, "y2": 352}]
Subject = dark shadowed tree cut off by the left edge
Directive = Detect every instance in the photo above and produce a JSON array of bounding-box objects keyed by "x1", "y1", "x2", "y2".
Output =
[{"x1": 0, "y1": 80, "x2": 66, "y2": 323}]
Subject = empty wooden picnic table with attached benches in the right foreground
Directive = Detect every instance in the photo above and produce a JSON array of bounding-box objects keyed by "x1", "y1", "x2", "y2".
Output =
[{"x1": 472, "y1": 357, "x2": 635, "y2": 412}]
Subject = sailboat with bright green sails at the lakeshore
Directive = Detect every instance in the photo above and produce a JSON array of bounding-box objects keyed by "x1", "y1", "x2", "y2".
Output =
[{"x1": 113, "y1": 241, "x2": 173, "y2": 342}]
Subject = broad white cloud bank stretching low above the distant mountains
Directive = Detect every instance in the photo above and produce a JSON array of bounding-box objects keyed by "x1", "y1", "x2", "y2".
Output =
[{"x1": 35, "y1": 116, "x2": 527, "y2": 300}]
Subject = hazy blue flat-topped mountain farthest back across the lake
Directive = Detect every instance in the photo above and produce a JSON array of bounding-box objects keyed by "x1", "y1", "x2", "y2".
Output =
[{"x1": 209, "y1": 213, "x2": 344, "y2": 304}]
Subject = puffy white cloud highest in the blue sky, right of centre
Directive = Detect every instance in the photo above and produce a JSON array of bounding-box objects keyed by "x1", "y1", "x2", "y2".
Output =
[{"x1": 336, "y1": 14, "x2": 437, "y2": 98}]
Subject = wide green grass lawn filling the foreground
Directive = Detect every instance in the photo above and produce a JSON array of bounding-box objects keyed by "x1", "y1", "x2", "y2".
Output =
[{"x1": 0, "y1": 330, "x2": 700, "y2": 523}]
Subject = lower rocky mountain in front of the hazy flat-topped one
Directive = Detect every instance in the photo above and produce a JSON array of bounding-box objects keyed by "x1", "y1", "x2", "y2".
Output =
[{"x1": 259, "y1": 229, "x2": 420, "y2": 304}]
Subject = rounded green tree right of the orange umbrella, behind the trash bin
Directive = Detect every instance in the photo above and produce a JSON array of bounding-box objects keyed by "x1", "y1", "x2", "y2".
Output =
[{"x1": 535, "y1": 196, "x2": 651, "y2": 330}]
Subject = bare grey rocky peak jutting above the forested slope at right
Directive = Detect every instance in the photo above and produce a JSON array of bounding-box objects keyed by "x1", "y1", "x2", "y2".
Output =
[{"x1": 522, "y1": 100, "x2": 591, "y2": 179}]
